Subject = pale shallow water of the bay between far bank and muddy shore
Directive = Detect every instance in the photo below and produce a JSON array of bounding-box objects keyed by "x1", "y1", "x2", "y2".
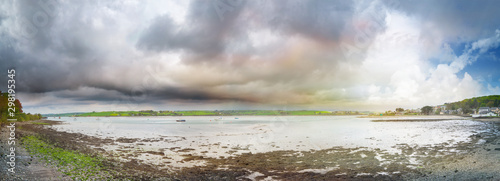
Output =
[{"x1": 49, "y1": 116, "x2": 489, "y2": 154}]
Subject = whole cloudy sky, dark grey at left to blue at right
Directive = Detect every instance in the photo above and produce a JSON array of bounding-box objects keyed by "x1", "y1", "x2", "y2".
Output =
[{"x1": 0, "y1": 0, "x2": 500, "y2": 113}]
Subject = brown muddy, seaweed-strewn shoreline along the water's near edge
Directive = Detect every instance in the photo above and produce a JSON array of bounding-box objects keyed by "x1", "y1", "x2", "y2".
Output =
[{"x1": 2, "y1": 120, "x2": 500, "y2": 180}]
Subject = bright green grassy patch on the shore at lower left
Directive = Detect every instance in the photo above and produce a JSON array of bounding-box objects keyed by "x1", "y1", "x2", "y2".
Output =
[{"x1": 22, "y1": 136, "x2": 110, "y2": 180}]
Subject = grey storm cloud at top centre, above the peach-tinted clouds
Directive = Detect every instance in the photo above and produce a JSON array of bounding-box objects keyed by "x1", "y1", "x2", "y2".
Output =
[{"x1": 137, "y1": 0, "x2": 362, "y2": 60}]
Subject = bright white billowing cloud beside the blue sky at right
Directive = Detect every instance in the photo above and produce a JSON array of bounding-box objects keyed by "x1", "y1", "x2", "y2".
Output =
[{"x1": 342, "y1": 12, "x2": 490, "y2": 109}]
